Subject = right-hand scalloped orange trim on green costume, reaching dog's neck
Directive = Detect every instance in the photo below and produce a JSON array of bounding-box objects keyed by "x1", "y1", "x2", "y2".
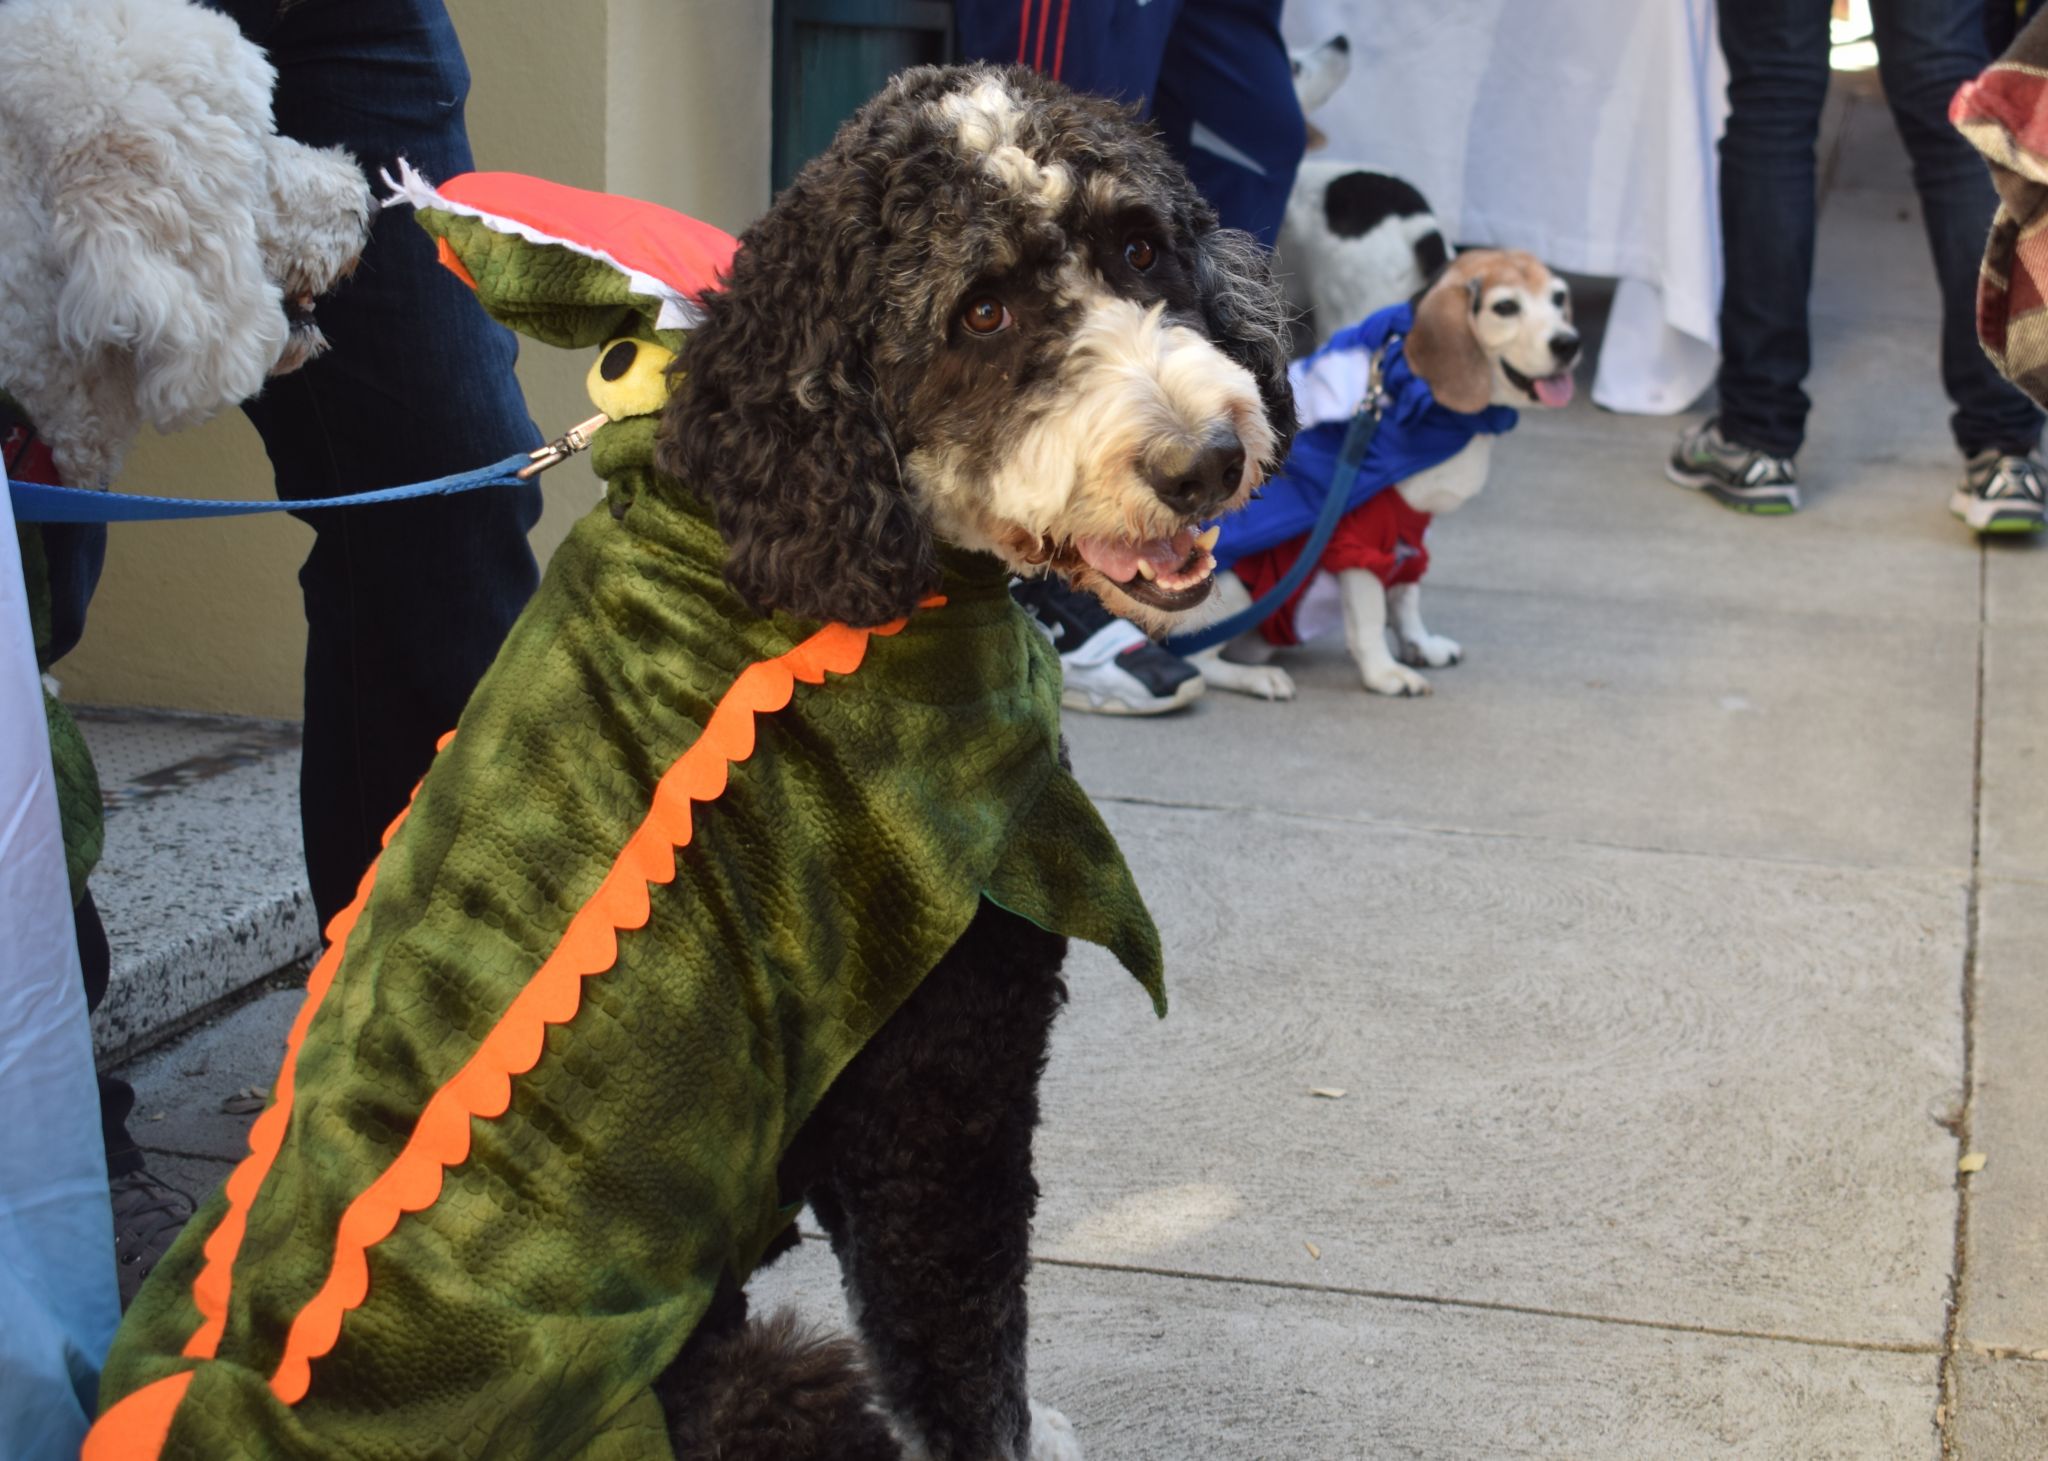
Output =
[{"x1": 270, "y1": 596, "x2": 946, "y2": 1406}]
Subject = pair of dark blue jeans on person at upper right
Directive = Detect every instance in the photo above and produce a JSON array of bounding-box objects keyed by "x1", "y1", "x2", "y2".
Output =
[{"x1": 1718, "y1": 0, "x2": 2042, "y2": 457}]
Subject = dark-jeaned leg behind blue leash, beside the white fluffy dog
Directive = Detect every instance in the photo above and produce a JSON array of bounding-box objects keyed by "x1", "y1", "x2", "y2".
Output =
[{"x1": 231, "y1": 0, "x2": 541, "y2": 926}]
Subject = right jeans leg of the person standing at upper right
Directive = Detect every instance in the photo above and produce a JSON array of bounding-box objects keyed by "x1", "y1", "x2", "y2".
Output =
[{"x1": 1870, "y1": 0, "x2": 2042, "y2": 457}]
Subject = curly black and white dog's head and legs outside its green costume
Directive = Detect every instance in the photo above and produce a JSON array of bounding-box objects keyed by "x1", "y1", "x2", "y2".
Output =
[{"x1": 662, "y1": 66, "x2": 1294, "y2": 1461}]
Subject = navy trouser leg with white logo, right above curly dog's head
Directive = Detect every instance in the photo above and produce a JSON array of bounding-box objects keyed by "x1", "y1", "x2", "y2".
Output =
[{"x1": 1153, "y1": 0, "x2": 1309, "y2": 248}]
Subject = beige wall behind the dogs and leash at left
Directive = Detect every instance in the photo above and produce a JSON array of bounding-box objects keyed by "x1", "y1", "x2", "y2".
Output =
[{"x1": 57, "y1": 0, "x2": 770, "y2": 717}]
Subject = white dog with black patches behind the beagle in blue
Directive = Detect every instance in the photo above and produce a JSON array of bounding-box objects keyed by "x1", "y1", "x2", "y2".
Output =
[{"x1": 1278, "y1": 35, "x2": 1452, "y2": 344}]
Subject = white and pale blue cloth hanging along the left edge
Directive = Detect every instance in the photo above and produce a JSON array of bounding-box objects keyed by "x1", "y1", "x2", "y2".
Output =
[{"x1": 0, "y1": 492, "x2": 121, "y2": 1461}]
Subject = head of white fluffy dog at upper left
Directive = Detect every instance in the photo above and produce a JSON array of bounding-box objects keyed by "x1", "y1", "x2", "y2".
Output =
[{"x1": 0, "y1": 0, "x2": 371, "y2": 488}]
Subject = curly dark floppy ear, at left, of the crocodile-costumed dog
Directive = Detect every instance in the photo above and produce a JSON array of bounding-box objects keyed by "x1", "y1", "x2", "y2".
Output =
[{"x1": 655, "y1": 172, "x2": 938, "y2": 625}]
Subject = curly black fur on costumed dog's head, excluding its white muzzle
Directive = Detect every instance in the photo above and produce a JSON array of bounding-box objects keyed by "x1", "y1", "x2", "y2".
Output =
[{"x1": 657, "y1": 66, "x2": 1294, "y2": 625}]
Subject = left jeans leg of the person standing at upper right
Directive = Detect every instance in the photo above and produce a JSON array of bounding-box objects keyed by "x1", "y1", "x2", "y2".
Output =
[{"x1": 1718, "y1": 0, "x2": 1829, "y2": 457}]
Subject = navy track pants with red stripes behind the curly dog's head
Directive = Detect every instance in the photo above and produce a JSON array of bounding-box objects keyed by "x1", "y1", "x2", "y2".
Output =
[{"x1": 954, "y1": 0, "x2": 1307, "y2": 248}]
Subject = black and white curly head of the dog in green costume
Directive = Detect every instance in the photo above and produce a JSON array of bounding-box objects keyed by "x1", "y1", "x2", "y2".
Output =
[{"x1": 670, "y1": 68, "x2": 1294, "y2": 633}]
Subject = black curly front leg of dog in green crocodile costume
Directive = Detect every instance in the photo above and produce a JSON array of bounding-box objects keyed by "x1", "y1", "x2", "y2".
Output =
[{"x1": 805, "y1": 904, "x2": 1081, "y2": 1461}]
